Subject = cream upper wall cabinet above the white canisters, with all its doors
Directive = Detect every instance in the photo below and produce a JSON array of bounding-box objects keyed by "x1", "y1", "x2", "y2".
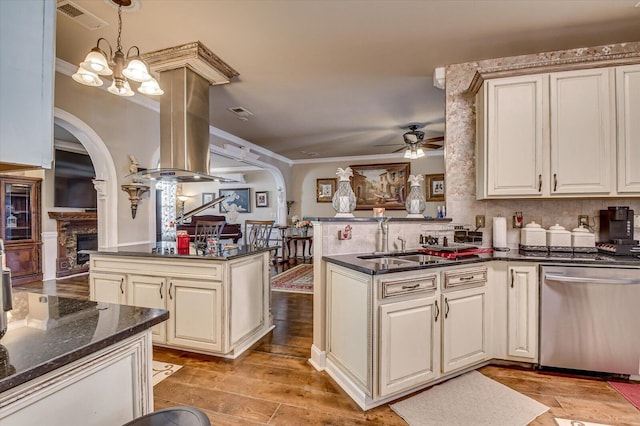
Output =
[{"x1": 476, "y1": 65, "x2": 640, "y2": 199}]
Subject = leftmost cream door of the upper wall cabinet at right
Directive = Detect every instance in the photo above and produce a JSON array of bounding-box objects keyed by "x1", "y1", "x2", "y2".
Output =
[{"x1": 479, "y1": 75, "x2": 547, "y2": 196}]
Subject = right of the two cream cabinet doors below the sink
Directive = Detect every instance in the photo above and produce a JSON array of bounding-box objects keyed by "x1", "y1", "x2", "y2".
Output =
[{"x1": 442, "y1": 287, "x2": 488, "y2": 373}]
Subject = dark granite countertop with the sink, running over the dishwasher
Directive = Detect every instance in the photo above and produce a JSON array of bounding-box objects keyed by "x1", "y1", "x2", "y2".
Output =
[{"x1": 322, "y1": 251, "x2": 640, "y2": 275}]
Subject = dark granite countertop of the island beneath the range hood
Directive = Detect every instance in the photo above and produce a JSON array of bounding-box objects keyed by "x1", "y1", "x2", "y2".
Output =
[{"x1": 80, "y1": 242, "x2": 279, "y2": 260}]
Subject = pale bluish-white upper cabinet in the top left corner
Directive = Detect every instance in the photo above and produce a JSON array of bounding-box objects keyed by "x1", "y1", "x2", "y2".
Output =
[{"x1": 0, "y1": 0, "x2": 56, "y2": 170}]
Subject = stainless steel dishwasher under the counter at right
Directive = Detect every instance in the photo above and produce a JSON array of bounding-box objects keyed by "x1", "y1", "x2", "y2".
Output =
[{"x1": 539, "y1": 266, "x2": 640, "y2": 375}]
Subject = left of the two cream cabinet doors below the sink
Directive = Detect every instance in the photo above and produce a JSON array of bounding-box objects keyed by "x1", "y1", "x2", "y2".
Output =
[{"x1": 379, "y1": 296, "x2": 440, "y2": 397}]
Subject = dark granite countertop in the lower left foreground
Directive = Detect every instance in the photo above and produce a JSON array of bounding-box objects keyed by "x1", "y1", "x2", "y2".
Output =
[{"x1": 0, "y1": 292, "x2": 169, "y2": 392}]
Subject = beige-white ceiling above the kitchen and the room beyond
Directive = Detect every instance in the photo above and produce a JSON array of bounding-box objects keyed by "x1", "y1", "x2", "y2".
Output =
[{"x1": 56, "y1": 0, "x2": 640, "y2": 159}]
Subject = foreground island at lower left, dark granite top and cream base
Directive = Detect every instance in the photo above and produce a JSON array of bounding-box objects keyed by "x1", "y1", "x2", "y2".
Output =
[{"x1": 0, "y1": 293, "x2": 169, "y2": 426}]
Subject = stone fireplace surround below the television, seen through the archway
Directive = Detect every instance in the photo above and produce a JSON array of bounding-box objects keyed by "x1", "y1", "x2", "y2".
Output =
[{"x1": 49, "y1": 212, "x2": 98, "y2": 278}]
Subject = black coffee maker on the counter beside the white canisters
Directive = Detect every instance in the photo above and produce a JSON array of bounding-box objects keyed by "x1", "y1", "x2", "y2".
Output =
[{"x1": 598, "y1": 206, "x2": 638, "y2": 254}]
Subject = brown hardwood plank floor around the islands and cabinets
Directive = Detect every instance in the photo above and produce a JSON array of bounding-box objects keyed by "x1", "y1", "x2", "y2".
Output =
[{"x1": 14, "y1": 270, "x2": 640, "y2": 426}]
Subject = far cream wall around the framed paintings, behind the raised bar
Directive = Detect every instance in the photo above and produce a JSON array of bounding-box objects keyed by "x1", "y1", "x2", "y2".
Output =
[{"x1": 287, "y1": 152, "x2": 446, "y2": 221}]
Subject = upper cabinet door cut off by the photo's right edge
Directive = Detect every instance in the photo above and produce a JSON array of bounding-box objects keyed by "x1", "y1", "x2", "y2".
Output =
[{"x1": 616, "y1": 65, "x2": 640, "y2": 193}]
